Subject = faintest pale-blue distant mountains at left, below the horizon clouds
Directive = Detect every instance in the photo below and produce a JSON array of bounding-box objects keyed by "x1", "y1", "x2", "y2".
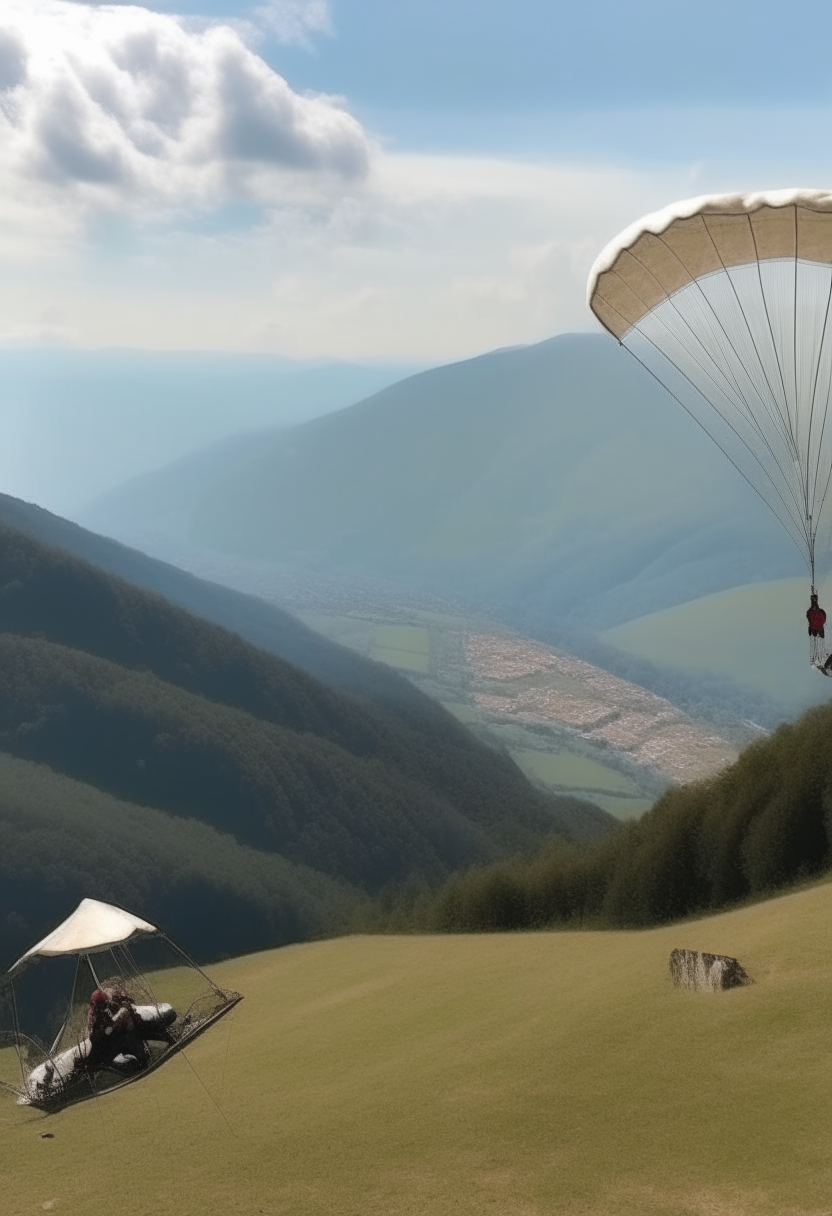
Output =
[{"x1": 0, "y1": 348, "x2": 416, "y2": 513}]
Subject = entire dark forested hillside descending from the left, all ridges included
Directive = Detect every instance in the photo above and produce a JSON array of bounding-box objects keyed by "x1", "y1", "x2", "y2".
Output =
[{"x1": 0, "y1": 497, "x2": 611, "y2": 957}]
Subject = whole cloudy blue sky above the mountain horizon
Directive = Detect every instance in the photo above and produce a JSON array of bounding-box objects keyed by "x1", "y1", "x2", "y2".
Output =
[{"x1": 0, "y1": 0, "x2": 832, "y2": 361}]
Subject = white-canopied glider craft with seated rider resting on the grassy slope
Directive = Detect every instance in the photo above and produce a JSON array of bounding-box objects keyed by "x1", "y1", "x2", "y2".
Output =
[{"x1": 0, "y1": 899, "x2": 242, "y2": 1109}]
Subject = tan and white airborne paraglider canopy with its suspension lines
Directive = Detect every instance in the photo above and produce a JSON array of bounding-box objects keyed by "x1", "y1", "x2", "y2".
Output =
[{"x1": 588, "y1": 190, "x2": 832, "y2": 598}]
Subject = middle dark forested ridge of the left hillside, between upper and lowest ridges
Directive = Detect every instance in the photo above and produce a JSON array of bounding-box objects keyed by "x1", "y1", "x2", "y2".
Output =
[{"x1": 0, "y1": 634, "x2": 591, "y2": 890}]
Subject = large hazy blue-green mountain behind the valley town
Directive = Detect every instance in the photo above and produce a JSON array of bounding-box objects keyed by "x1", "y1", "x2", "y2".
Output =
[{"x1": 84, "y1": 334, "x2": 802, "y2": 632}]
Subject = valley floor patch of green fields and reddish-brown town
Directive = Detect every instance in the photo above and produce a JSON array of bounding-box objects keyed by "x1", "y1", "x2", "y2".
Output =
[{"x1": 300, "y1": 604, "x2": 747, "y2": 818}]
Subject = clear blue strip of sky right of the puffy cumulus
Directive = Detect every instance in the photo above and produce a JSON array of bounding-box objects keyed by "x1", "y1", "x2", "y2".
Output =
[{"x1": 116, "y1": 0, "x2": 832, "y2": 114}]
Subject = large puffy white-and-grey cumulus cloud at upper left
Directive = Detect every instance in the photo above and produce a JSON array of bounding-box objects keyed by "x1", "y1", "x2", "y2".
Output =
[{"x1": 0, "y1": 0, "x2": 371, "y2": 223}]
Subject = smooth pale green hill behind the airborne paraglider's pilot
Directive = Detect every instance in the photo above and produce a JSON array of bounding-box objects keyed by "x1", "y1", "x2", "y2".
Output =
[{"x1": 602, "y1": 579, "x2": 832, "y2": 705}]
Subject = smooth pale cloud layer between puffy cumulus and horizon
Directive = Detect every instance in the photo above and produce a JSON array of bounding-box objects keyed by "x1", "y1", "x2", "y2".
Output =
[{"x1": 0, "y1": 148, "x2": 700, "y2": 361}]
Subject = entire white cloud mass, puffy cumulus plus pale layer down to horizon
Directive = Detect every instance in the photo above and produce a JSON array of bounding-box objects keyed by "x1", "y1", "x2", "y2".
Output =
[{"x1": 0, "y1": 0, "x2": 822, "y2": 360}]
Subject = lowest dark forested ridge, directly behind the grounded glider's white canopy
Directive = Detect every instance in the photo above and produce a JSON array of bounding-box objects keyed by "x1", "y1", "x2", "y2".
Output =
[{"x1": 0, "y1": 751, "x2": 350, "y2": 970}]
